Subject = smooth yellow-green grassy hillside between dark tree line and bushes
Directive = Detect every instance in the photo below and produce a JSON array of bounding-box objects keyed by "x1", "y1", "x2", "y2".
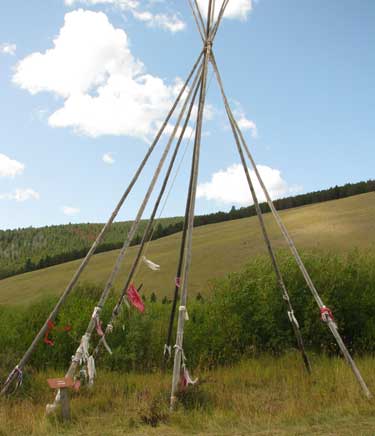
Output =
[{"x1": 0, "y1": 192, "x2": 375, "y2": 304}]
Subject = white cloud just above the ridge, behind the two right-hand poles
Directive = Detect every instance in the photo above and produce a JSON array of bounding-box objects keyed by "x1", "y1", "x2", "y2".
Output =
[{"x1": 197, "y1": 164, "x2": 301, "y2": 205}]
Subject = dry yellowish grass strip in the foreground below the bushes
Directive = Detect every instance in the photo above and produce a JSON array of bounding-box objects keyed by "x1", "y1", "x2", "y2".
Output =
[{"x1": 0, "y1": 353, "x2": 375, "y2": 436}]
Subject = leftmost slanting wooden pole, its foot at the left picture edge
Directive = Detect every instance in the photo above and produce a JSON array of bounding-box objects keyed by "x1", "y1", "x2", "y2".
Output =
[{"x1": 0, "y1": 52, "x2": 203, "y2": 395}]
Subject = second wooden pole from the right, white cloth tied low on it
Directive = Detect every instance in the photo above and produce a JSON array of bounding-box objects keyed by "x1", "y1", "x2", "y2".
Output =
[{"x1": 211, "y1": 56, "x2": 311, "y2": 373}]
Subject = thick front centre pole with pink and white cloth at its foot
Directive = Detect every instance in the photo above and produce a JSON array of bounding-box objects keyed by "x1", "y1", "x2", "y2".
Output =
[{"x1": 170, "y1": 0, "x2": 212, "y2": 410}]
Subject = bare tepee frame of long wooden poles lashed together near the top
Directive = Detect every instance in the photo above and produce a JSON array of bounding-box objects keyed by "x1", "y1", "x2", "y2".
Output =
[{"x1": 1, "y1": 0, "x2": 371, "y2": 411}]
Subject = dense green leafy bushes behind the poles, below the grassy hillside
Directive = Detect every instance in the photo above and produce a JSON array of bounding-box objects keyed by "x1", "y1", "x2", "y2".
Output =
[{"x1": 0, "y1": 252, "x2": 375, "y2": 376}]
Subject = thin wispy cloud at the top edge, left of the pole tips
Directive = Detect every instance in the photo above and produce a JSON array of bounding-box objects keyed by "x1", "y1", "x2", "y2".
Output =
[{"x1": 65, "y1": 0, "x2": 186, "y2": 33}]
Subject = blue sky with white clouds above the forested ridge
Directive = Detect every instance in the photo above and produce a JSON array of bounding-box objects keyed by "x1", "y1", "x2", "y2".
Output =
[{"x1": 0, "y1": 0, "x2": 375, "y2": 229}]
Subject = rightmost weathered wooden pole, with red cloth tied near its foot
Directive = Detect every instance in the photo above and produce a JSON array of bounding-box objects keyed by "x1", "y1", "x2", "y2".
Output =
[{"x1": 211, "y1": 54, "x2": 372, "y2": 398}]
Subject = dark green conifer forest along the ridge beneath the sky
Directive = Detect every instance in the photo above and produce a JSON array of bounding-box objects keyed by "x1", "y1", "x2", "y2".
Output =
[{"x1": 0, "y1": 180, "x2": 375, "y2": 279}]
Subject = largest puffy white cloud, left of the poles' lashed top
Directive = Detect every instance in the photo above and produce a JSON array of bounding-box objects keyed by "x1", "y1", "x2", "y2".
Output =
[{"x1": 13, "y1": 9, "x2": 188, "y2": 140}]
